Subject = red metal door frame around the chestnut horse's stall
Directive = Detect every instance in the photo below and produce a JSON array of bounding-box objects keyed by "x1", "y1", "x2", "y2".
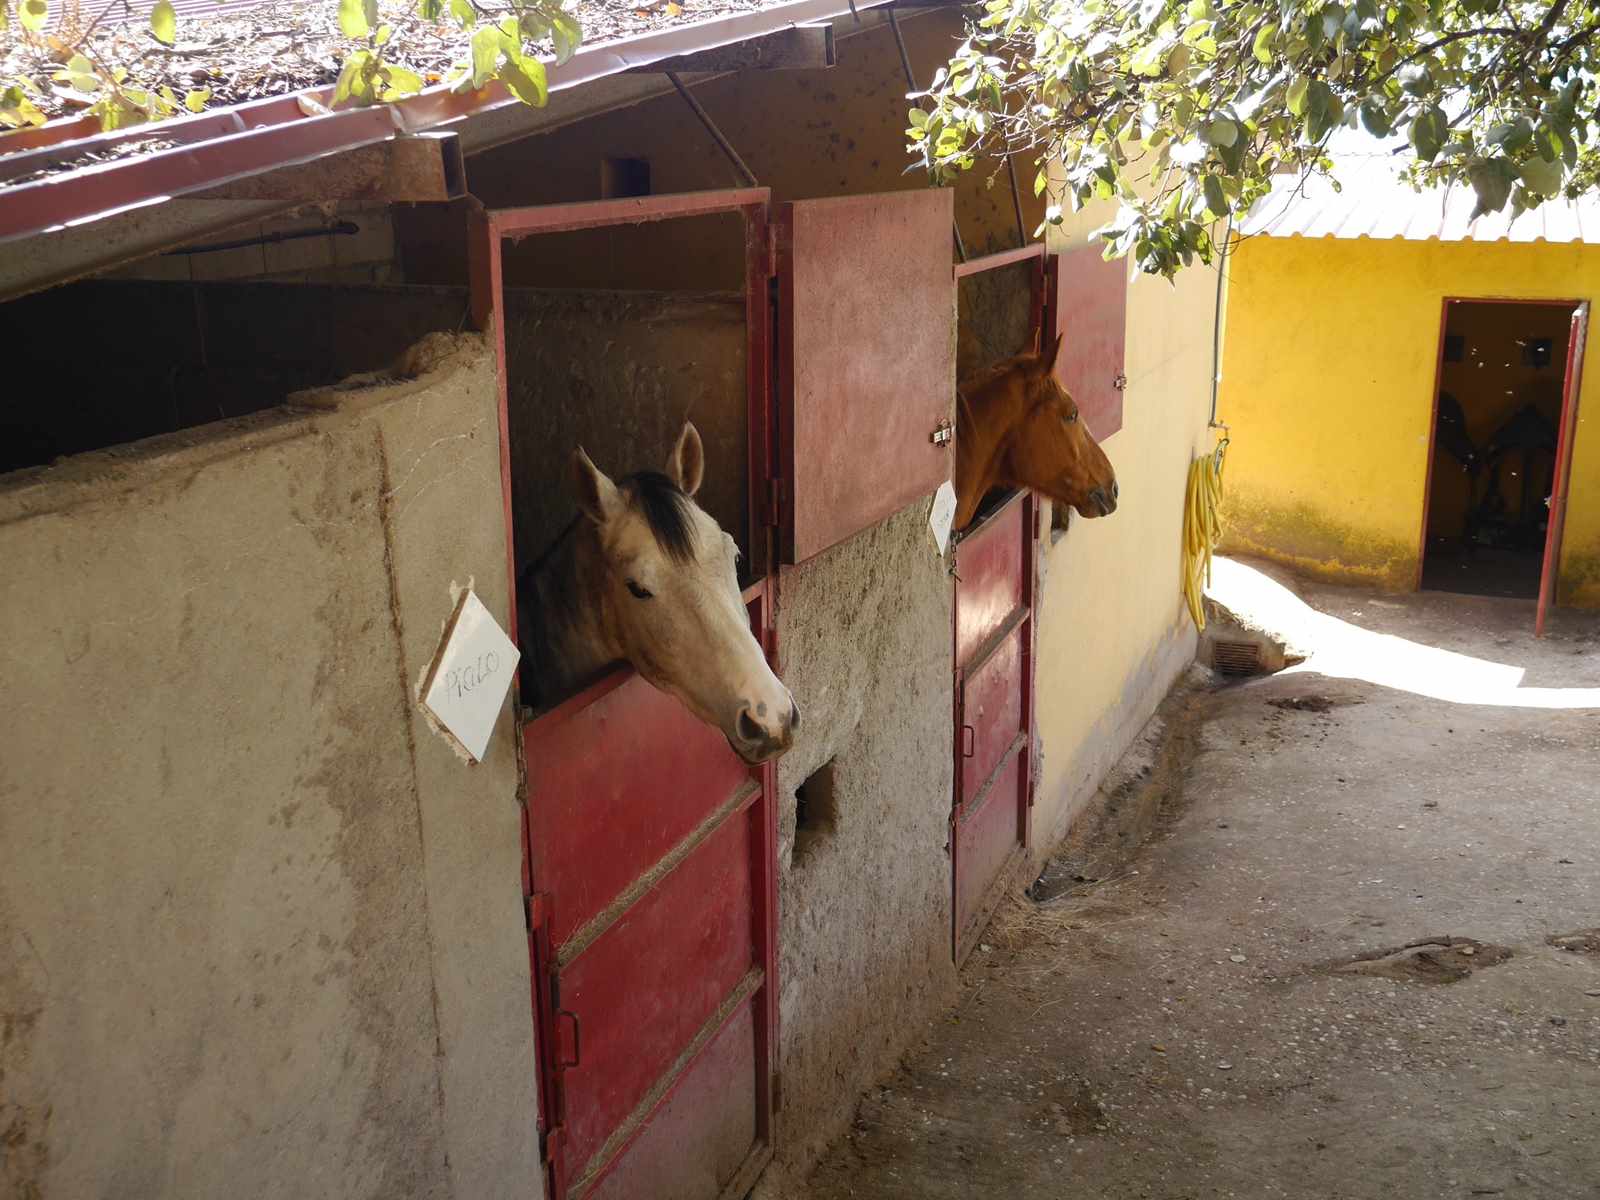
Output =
[{"x1": 946, "y1": 242, "x2": 1059, "y2": 966}]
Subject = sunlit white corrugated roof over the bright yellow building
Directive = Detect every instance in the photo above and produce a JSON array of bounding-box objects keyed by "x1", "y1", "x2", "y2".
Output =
[{"x1": 1238, "y1": 154, "x2": 1600, "y2": 245}]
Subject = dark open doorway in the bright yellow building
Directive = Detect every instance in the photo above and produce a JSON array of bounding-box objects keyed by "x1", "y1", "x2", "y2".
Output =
[{"x1": 1421, "y1": 301, "x2": 1576, "y2": 600}]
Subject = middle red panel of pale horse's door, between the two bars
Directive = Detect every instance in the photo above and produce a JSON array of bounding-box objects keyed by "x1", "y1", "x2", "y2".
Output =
[{"x1": 557, "y1": 808, "x2": 755, "y2": 1170}]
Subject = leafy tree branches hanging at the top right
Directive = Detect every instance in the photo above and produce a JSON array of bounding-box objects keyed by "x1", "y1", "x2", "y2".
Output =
[{"x1": 907, "y1": 0, "x2": 1600, "y2": 277}]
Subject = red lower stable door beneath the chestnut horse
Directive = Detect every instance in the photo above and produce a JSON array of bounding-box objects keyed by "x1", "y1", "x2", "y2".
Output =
[{"x1": 950, "y1": 491, "x2": 1038, "y2": 963}]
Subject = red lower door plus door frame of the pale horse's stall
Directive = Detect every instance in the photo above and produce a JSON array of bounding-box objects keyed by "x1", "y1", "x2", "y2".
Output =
[{"x1": 472, "y1": 189, "x2": 778, "y2": 1200}]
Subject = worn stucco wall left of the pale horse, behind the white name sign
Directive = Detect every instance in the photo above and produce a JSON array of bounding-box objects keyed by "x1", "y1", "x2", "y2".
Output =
[{"x1": 0, "y1": 338, "x2": 539, "y2": 1198}]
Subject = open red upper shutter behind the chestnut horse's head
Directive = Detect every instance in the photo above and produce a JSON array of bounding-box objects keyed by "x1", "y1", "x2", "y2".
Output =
[{"x1": 1054, "y1": 246, "x2": 1128, "y2": 442}]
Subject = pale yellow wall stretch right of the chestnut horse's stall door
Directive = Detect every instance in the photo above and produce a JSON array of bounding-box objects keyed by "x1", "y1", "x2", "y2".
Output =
[{"x1": 1034, "y1": 210, "x2": 1216, "y2": 854}]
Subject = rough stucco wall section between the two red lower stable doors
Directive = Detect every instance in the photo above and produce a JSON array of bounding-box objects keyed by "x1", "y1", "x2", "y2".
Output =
[{"x1": 758, "y1": 501, "x2": 955, "y2": 1195}]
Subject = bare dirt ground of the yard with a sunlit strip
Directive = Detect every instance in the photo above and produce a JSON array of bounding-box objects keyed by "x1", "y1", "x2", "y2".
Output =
[{"x1": 803, "y1": 563, "x2": 1600, "y2": 1200}]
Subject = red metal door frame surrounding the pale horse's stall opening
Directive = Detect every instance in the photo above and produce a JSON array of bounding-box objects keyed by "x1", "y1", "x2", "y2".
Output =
[{"x1": 467, "y1": 187, "x2": 778, "y2": 1200}]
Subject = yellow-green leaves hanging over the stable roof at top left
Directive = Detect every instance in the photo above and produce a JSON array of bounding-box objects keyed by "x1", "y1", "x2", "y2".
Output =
[{"x1": 0, "y1": 0, "x2": 582, "y2": 130}]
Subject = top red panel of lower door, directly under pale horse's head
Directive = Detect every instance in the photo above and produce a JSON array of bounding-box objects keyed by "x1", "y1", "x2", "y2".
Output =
[{"x1": 525, "y1": 672, "x2": 750, "y2": 946}]
